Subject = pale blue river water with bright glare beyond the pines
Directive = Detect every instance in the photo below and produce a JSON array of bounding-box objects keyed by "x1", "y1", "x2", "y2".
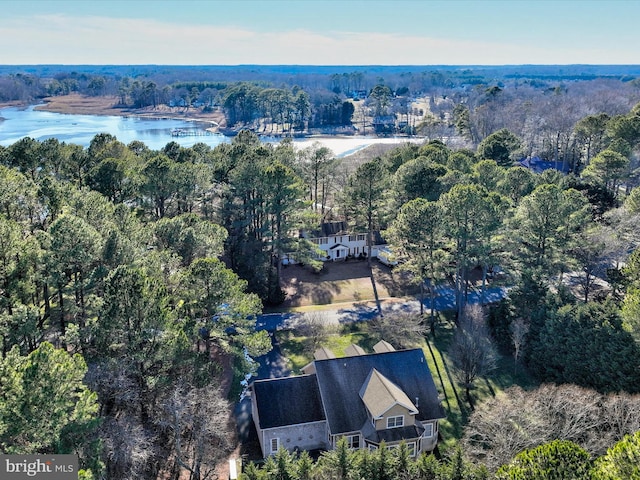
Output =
[{"x1": 0, "y1": 106, "x2": 422, "y2": 157}]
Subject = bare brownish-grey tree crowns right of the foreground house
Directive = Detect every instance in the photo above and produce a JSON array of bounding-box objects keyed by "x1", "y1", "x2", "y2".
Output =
[{"x1": 463, "y1": 385, "x2": 640, "y2": 470}]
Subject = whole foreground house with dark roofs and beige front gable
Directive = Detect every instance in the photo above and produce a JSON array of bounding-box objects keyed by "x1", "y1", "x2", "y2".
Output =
[{"x1": 250, "y1": 342, "x2": 445, "y2": 457}]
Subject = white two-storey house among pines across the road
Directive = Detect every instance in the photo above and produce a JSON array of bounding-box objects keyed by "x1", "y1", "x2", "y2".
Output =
[{"x1": 302, "y1": 222, "x2": 385, "y2": 261}]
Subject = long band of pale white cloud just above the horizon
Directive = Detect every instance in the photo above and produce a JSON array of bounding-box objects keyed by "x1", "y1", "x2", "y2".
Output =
[{"x1": 0, "y1": 15, "x2": 639, "y2": 65}]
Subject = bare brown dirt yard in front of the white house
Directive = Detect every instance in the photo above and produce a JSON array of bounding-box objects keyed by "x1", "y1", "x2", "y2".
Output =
[{"x1": 282, "y1": 260, "x2": 418, "y2": 308}]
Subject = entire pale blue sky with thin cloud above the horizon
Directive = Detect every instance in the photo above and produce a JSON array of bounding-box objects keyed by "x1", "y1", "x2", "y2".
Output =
[{"x1": 0, "y1": 0, "x2": 640, "y2": 65}]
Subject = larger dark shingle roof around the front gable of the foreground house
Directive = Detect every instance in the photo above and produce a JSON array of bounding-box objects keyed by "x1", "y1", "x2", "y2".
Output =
[{"x1": 315, "y1": 349, "x2": 445, "y2": 435}]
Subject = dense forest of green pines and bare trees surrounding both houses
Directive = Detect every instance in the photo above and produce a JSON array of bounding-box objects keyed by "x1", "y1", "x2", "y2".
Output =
[{"x1": 0, "y1": 65, "x2": 640, "y2": 479}]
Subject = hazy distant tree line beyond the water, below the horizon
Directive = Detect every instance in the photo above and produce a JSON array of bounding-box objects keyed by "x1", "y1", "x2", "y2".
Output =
[{"x1": 5, "y1": 67, "x2": 640, "y2": 143}]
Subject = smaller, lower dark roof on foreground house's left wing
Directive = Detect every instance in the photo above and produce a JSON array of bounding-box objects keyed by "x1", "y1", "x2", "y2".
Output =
[{"x1": 253, "y1": 375, "x2": 325, "y2": 429}]
